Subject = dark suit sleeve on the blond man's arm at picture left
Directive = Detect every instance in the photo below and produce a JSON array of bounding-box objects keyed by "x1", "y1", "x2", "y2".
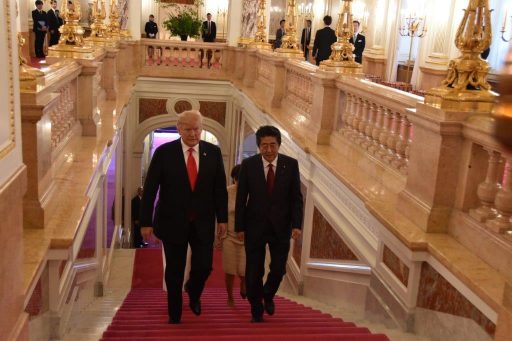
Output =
[{"x1": 140, "y1": 148, "x2": 164, "y2": 227}]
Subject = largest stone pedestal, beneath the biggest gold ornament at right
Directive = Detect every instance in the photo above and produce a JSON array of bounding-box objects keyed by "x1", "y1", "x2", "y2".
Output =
[{"x1": 397, "y1": 103, "x2": 469, "y2": 232}]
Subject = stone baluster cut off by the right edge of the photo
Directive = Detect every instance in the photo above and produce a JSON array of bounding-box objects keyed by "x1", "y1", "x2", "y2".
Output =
[{"x1": 487, "y1": 156, "x2": 512, "y2": 233}]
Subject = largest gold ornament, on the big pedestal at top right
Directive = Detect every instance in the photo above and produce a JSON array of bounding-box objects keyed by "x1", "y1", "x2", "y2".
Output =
[{"x1": 425, "y1": 0, "x2": 497, "y2": 112}]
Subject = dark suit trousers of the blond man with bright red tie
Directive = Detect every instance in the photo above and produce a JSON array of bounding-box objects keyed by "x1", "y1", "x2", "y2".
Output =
[{"x1": 162, "y1": 222, "x2": 213, "y2": 320}]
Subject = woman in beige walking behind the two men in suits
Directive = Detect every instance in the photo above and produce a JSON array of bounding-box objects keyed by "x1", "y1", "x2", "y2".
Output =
[{"x1": 220, "y1": 165, "x2": 246, "y2": 306}]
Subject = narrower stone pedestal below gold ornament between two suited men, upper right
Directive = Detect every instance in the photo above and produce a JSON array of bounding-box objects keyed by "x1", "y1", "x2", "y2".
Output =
[{"x1": 307, "y1": 71, "x2": 338, "y2": 144}]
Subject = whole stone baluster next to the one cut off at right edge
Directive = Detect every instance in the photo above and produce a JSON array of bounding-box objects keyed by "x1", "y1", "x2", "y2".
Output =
[{"x1": 469, "y1": 150, "x2": 502, "y2": 223}]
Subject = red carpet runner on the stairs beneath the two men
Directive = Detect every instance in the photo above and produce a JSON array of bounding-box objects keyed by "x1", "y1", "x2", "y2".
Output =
[{"x1": 101, "y1": 249, "x2": 389, "y2": 341}]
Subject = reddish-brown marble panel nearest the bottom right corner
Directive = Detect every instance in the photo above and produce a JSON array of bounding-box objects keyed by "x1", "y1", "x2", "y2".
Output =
[{"x1": 417, "y1": 263, "x2": 496, "y2": 336}]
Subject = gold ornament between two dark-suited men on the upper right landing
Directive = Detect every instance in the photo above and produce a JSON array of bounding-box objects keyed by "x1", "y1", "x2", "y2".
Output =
[{"x1": 320, "y1": 0, "x2": 362, "y2": 75}]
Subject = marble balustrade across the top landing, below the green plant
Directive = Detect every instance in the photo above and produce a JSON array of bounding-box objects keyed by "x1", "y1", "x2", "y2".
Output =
[{"x1": 141, "y1": 39, "x2": 228, "y2": 71}]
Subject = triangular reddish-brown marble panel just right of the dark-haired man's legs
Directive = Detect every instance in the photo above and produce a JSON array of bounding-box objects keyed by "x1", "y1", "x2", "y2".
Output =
[{"x1": 310, "y1": 207, "x2": 358, "y2": 260}]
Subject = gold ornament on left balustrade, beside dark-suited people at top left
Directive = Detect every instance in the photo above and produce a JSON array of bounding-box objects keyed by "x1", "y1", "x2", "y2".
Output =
[{"x1": 48, "y1": 0, "x2": 97, "y2": 59}]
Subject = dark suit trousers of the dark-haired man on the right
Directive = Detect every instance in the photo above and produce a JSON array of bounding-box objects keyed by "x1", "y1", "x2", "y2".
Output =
[{"x1": 245, "y1": 222, "x2": 290, "y2": 316}]
